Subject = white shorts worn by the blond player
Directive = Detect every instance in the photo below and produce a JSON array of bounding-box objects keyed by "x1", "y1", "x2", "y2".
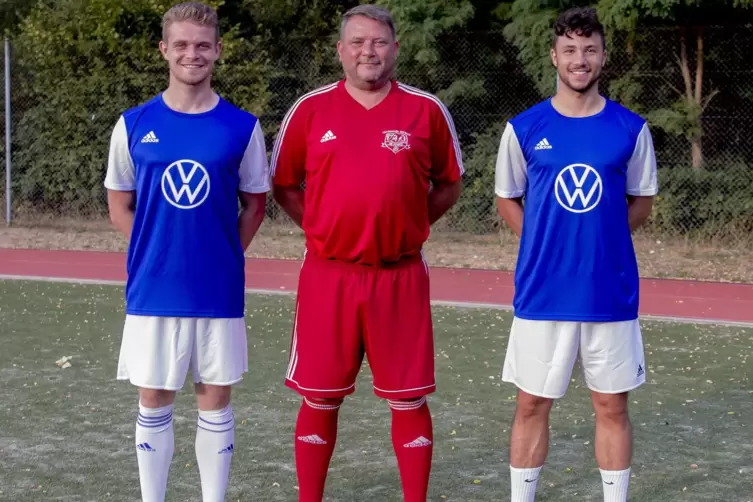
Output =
[{"x1": 117, "y1": 315, "x2": 248, "y2": 391}]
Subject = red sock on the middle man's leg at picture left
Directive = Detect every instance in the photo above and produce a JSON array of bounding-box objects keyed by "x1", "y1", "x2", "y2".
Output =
[{"x1": 295, "y1": 399, "x2": 342, "y2": 502}]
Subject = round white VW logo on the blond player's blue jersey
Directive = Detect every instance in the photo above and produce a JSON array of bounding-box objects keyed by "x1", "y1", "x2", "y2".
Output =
[{"x1": 162, "y1": 159, "x2": 210, "y2": 209}]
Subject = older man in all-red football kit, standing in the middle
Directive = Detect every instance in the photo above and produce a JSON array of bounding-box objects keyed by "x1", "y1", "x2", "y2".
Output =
[{"x1": 271, "y1": 5, "x2": 463, "y2": 502}]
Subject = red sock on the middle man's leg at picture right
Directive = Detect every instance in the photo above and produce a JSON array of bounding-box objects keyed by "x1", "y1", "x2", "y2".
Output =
[{"x1": 389, "y1": 397, "x2": 434, "y2": 502}]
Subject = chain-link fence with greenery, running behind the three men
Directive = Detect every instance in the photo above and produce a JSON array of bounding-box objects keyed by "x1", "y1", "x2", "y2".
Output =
[{"x1": 0, "y1": 27, "x2": 753, "y2": 264}]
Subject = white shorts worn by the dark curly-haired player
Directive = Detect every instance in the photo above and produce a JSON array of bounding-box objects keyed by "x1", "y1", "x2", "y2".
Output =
[{"x1": 502, "y1": 317, "x2": 646, "y2": 399}]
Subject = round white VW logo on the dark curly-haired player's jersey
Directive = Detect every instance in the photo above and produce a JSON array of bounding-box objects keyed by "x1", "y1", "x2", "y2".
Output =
[{"x1": 554, "y1": 164, "x2": 604, "y2": 213}]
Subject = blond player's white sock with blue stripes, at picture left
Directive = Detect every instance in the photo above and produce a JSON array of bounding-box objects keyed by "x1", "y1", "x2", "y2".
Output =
[{"x1": 136, "y1": 403, "x2": 175, "y2": 502}]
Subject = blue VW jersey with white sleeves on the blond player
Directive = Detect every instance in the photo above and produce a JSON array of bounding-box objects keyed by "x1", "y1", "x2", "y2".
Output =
[{"x1": 105, "y1": 95, "x2": 269, "y2": 318}]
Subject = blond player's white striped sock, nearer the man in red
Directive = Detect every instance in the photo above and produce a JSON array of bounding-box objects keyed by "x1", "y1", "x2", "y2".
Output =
[{"x1": 196, "y1": 406, "x2": 235, "y2": 502}]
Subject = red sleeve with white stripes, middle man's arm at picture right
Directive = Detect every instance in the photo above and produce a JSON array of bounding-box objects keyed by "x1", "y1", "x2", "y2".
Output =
[{"x1": 430, "y1": 99, "x2": 465, "y2": 183}]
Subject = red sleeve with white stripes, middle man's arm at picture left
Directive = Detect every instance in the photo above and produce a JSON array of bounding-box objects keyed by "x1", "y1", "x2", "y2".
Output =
[{"x1": 270, "y1": 101, "x2": 306, "y2": 188}]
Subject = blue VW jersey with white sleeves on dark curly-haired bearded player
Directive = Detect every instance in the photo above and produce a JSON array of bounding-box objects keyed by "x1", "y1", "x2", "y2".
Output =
[{"x1": 495, "y1": 100, "x2": 657, "y2": 322}]
